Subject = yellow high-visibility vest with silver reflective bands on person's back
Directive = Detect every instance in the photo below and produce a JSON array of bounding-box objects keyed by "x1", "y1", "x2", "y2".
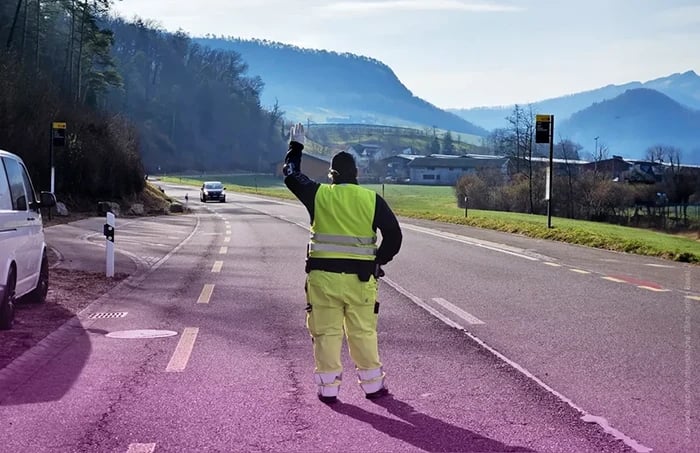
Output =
[{"x1": 308, "y1": 184, "x2": 377, "y2": 261}]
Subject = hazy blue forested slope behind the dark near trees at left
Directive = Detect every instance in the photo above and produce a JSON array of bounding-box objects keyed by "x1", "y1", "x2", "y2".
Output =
[{"x1": 106, "y1": 19, "x2": 285, "y2": 172}]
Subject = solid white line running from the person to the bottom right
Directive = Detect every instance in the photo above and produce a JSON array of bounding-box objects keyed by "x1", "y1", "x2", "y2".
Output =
[{"x1": 382, "y1": 277, "x2": 652, "y2": 453}]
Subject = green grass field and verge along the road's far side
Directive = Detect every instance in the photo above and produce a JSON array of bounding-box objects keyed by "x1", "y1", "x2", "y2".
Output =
[{"x1": 162, "y1": 175, "x2": 700, "y2": 263}]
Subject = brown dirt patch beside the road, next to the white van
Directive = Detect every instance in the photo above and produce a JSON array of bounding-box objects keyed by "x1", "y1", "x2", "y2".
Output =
[{"x1": 0, "y1": 254, "x2": 127, "y2": 369}]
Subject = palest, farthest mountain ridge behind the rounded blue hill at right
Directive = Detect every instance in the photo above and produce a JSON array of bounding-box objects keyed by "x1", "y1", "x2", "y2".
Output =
[{"x1": 450, "y1": 71, "x2": 700, "y2": 130}]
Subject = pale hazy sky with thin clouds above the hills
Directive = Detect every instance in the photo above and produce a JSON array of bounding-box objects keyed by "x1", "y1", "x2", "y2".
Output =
[{"x1": 114, "y1": 0, "x2": 700, "y2": 108}]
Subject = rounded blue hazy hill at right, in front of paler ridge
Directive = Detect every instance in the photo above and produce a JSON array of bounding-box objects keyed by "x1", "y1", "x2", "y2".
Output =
[{"x1": 557, "y1": 88, "x2": 700, "y2": 164}]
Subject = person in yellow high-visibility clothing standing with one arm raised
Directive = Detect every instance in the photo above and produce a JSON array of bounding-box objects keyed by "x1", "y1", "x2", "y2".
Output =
[{"x1": 283, "y1": 124, "x2": 403, "y2": 403}]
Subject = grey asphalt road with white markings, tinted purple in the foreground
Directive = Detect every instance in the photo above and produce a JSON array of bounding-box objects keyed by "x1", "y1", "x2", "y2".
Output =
[{"x1": 0, "y1": 186, "x2": 700, "y2": 452}]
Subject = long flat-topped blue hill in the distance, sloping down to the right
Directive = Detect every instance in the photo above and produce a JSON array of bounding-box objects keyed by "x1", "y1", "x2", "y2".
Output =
[{"x1": 195, "y1": 37, "x2": 486, "y2": 136}]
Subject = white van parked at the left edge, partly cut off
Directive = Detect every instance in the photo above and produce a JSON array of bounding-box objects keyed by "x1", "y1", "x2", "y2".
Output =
[{"x1": 0, "y1": 150, "x2": 56, "y2": 329}]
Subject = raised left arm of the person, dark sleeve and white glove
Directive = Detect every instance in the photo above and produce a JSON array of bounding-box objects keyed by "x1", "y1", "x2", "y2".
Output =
[{"x1": 282, "y1": 124, "x2": 320, "y2": 217}]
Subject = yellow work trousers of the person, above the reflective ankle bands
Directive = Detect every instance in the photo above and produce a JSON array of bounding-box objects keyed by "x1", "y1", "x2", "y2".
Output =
[{"x1": 306, "y1": 270, "x2": 382, "y2": 373}]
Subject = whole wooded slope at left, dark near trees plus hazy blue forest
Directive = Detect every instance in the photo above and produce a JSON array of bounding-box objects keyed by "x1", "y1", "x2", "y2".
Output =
[{"x1": 0, "y1": 0, "x2": 284, "y2": 198}]
